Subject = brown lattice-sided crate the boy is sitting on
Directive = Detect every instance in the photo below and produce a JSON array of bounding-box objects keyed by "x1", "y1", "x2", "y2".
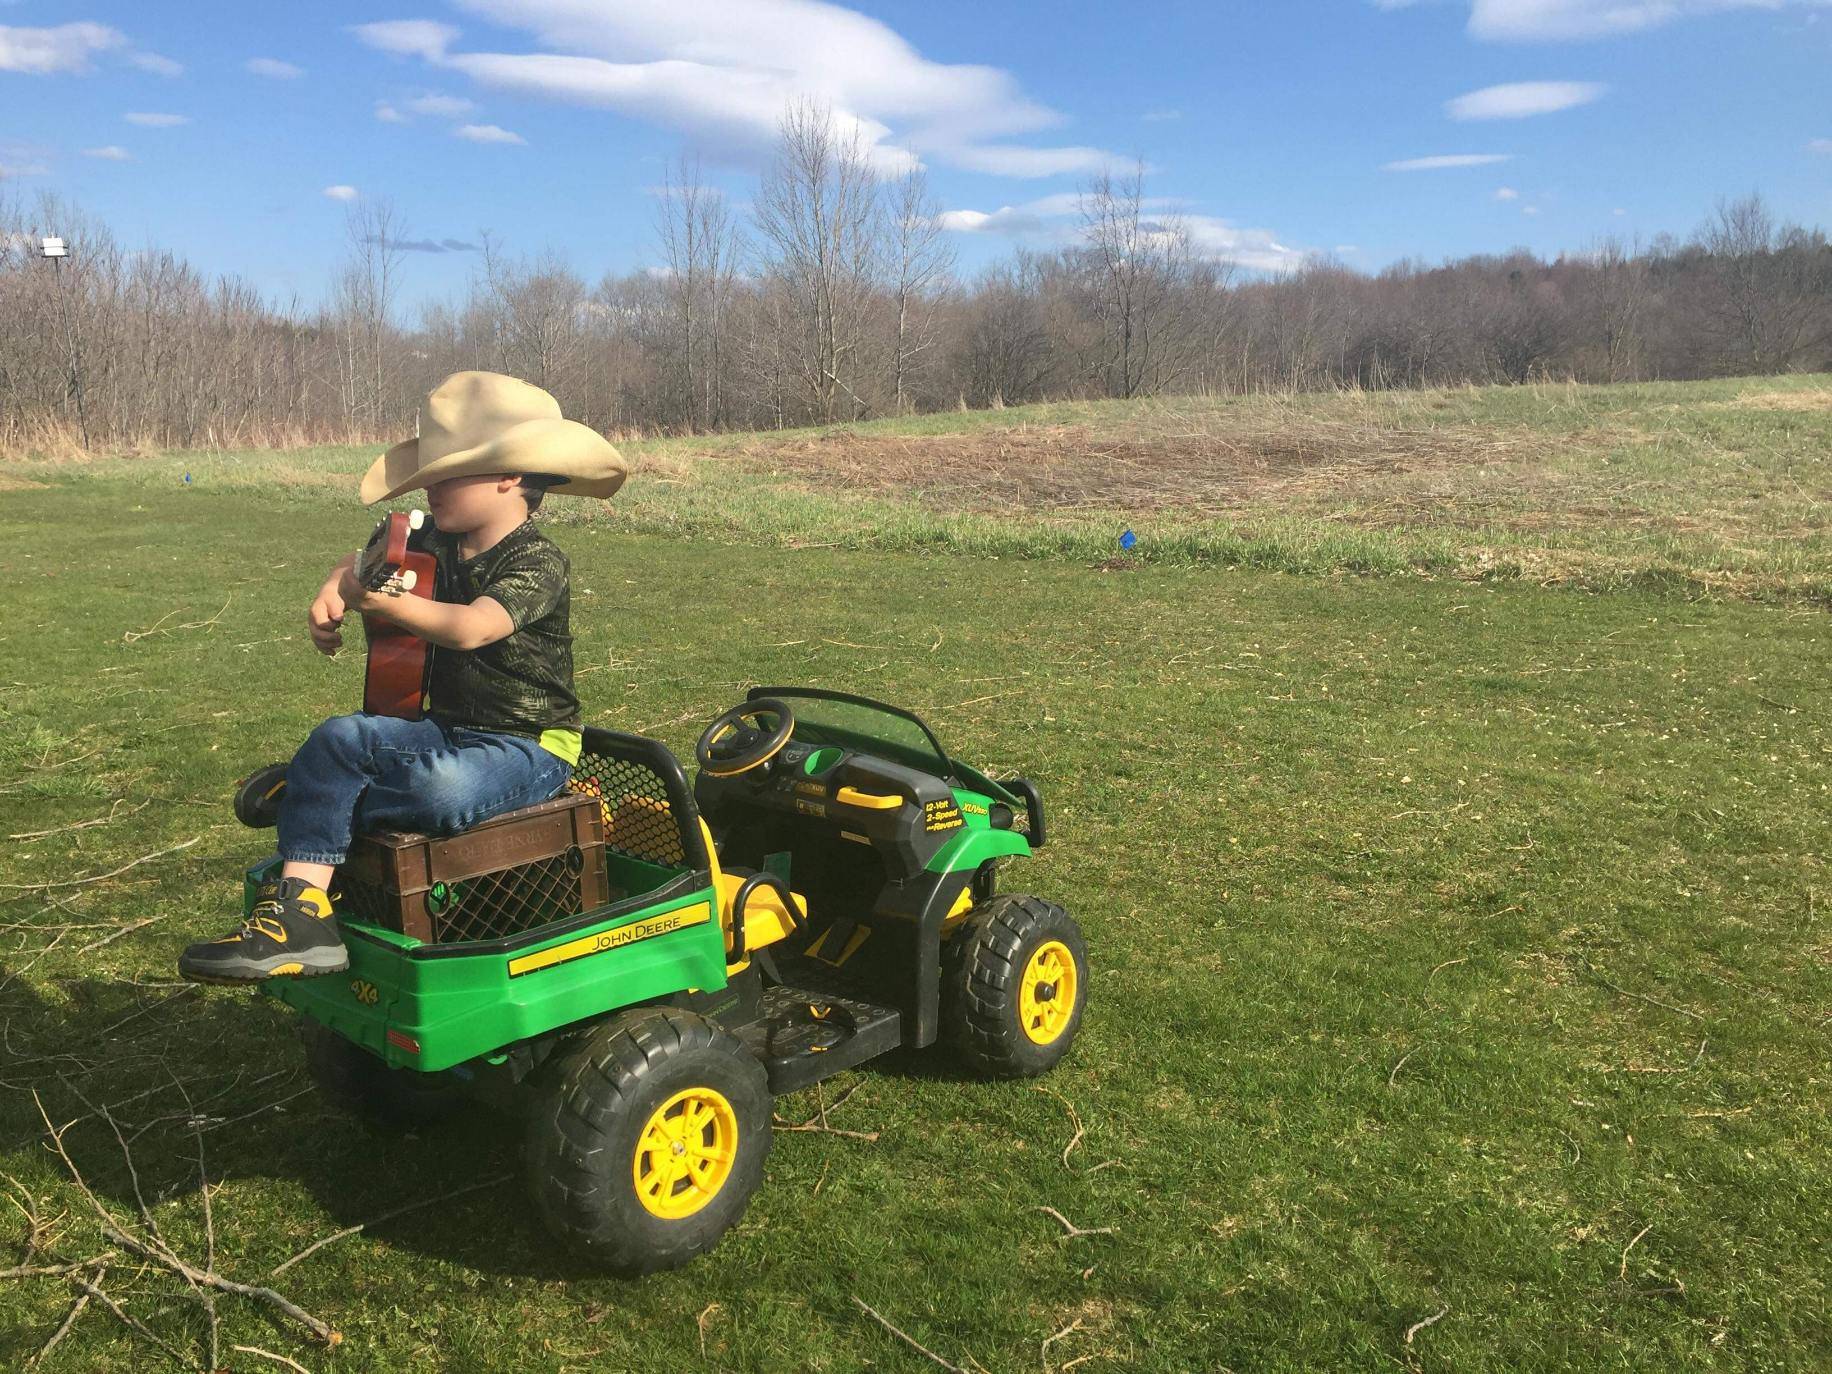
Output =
[{"x1": 332, "y1": 791, "x2": 608, "y2": 943}]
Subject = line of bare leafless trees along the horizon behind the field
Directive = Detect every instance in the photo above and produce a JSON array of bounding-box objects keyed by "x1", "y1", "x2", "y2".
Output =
[{"x1": 0, "y1": 104, "x2": 1832, "y2": 453}]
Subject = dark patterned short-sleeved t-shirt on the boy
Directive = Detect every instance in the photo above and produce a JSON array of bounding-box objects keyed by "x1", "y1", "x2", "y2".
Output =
[{"x1": 425, "y1": 520, "x2": 579, "y2": 764}]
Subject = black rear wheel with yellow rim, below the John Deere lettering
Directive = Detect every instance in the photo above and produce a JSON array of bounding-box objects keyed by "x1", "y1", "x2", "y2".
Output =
[{"x1": 524, "y1": 1008, "x2": 771, "y2": 1275}]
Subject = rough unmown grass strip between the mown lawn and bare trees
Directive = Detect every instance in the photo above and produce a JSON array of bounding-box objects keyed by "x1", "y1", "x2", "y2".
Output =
[{"x1": 17, "y1": 376, "x2": 1832, "y2": 601}]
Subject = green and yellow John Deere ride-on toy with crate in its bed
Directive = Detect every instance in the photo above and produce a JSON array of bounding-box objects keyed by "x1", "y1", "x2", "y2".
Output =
[{"x1": 247, "y1": 687, "x2": 1088, "y2": 1273}]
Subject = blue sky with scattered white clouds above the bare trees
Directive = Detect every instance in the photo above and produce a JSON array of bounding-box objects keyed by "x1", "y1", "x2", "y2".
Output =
[{"x1": 0, "y1": 0, "x2": 1832, "y2": 308}]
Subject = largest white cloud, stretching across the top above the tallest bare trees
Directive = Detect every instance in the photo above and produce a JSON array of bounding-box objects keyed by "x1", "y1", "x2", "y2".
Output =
[{"x1": 354, "y1": 0, "x2": 1112, "y2": 176}]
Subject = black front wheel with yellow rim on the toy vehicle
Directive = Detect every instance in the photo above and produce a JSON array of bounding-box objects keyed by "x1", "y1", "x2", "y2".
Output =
[{"x1": 942, "y1": 894, "x2": 1088, "y2": 1077}]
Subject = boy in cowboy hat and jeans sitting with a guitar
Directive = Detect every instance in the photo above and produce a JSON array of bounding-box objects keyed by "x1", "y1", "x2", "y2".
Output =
[{"x1": 178, "y1": 372, "x2": 627, "y2": 984}]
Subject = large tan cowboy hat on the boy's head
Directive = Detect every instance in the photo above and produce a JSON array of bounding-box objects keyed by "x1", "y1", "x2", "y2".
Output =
[{"x1": 363, "y1": 372, "x2": 630, "y2": 506}]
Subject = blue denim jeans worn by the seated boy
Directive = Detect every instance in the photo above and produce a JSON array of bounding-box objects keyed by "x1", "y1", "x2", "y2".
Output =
[{"x1": 280, "y1": 713, "x2": 572, "y2": 863}]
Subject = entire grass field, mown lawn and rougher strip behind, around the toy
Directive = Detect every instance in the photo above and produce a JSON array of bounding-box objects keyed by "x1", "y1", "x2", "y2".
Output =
[{"x1": 0, "y1": 377, "x2": 1832, "y2": 1374}]
